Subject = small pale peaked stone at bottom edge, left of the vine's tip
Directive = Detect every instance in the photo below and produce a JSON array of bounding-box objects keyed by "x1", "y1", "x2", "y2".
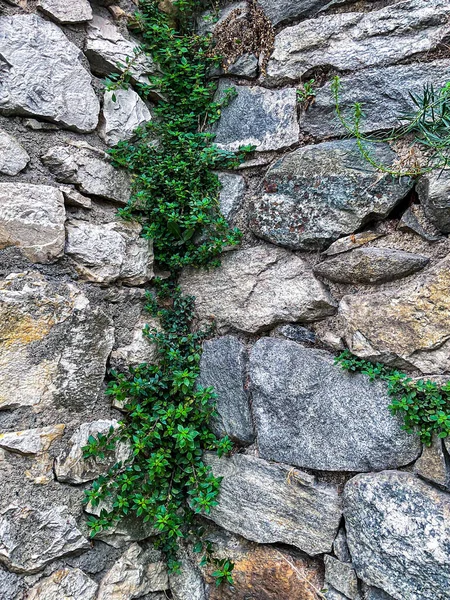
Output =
[{"x1": 97, "y1": 544, "x2": 169, "y2": 600}]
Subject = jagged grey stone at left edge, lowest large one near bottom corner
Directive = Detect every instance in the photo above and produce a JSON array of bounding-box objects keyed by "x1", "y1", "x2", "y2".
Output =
[{"x1": 0, "y1": 505, "x2": 90, "y2": 574}]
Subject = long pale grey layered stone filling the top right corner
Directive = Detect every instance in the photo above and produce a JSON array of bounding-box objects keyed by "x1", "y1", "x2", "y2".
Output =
[{"x1": 267, "y1": 0, "x2": 450, "y2": 84}]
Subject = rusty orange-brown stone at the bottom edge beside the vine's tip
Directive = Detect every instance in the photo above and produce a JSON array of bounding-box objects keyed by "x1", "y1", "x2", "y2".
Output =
[{"x1": 206, "y1": 532, "x2": 323, "y2": 600}]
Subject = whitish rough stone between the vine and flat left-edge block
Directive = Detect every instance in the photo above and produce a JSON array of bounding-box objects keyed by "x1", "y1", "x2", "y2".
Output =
[{"x1": 66, "y1": 220, "x2": 153, "y2": 285}]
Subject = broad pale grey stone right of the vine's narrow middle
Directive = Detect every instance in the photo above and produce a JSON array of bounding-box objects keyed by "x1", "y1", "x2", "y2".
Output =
[{"x1": 180, "y1": 245, "x2": 335, "y2": 333}]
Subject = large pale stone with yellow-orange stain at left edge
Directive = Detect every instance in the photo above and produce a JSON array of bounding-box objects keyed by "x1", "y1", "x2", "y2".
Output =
[{"x1": 0, "y1": 272, "x2": 113, "y2": 409}]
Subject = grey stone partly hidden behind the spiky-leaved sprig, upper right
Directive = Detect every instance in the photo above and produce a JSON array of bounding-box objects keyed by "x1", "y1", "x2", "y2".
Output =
[{"x1": 300, "y1": 61, "x2": 450, "y2": 138}]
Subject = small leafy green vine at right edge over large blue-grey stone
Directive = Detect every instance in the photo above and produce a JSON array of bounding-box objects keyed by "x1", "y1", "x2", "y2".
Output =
[{"x1": 336, "y1": 350, "x2": 450, "y2": 446}]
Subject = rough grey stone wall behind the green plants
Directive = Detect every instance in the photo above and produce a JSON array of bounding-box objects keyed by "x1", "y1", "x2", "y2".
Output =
[{"x1": 0, "y1": 0, "x2": 450, "y2": 600}]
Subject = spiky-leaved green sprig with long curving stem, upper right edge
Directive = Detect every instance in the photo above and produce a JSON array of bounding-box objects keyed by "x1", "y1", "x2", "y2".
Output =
[{"x1": 331, "y1": 76, "x2": 450, "y2": 177}]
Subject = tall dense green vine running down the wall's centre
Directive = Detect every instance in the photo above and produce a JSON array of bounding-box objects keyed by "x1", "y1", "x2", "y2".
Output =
[{"x1": 83, "y1": 0, "x2": 253, "y2": 583}]
